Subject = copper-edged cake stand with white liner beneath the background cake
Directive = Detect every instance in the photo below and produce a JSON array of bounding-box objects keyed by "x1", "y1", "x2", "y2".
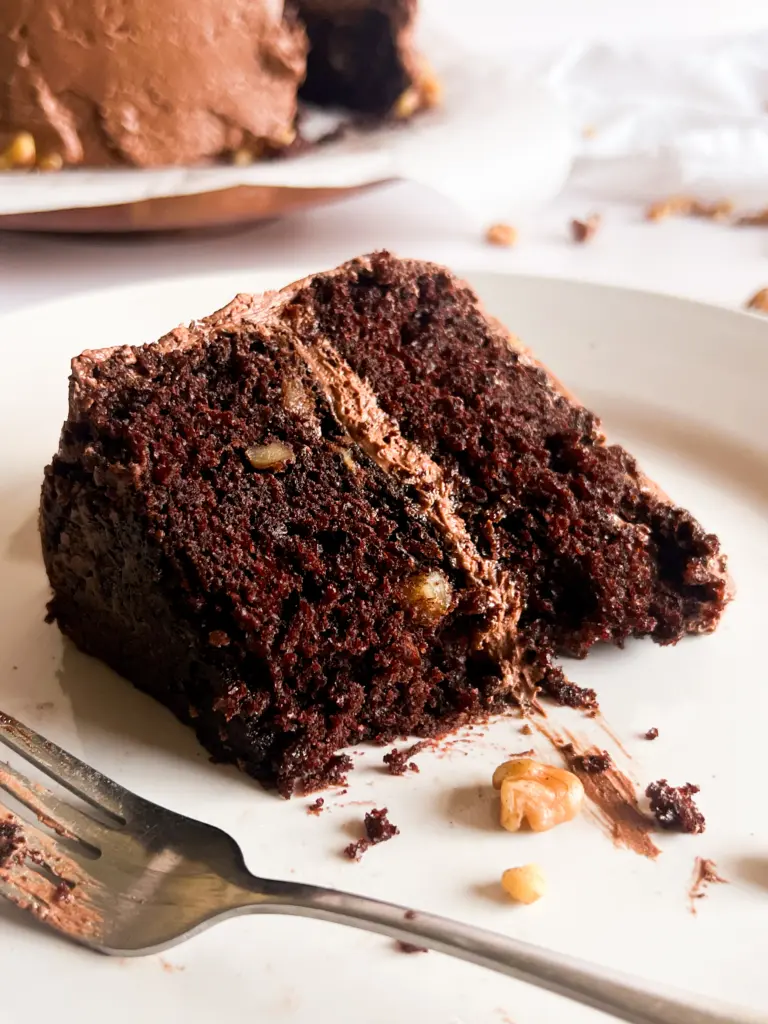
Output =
[{"x1": 0, "y1": 65, "x2": 574, "y2": 232}]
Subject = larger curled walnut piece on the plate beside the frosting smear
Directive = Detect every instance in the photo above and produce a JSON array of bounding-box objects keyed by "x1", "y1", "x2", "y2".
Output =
[{"x1": 493, "y1": 758, "x2": 584, "y2": 831}]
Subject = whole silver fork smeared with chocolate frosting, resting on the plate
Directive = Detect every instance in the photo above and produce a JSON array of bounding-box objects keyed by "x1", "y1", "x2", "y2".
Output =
[{"x1": 0, "y1": 713, "x2": 768, "y2": 1024}]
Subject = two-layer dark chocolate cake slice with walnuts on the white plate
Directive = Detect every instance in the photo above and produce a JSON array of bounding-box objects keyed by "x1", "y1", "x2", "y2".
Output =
[{"x1": 41, "y1": 253, "x2": 728, "y2": 795}]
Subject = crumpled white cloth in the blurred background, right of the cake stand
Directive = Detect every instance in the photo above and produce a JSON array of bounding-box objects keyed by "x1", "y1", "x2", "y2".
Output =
[{"x1": 536, "y1": 33, "x2": 768, "y2": 206}]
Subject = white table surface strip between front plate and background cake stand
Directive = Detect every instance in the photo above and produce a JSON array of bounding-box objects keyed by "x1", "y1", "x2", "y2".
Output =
[{"x1": 0, "y1": 183, "x2": 768, "y2": 317}]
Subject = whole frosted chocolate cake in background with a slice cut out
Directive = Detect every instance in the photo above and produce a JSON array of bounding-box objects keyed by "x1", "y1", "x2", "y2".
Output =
[{"x1": 0, "y1": 0, "x2": 434, "y2": 169}]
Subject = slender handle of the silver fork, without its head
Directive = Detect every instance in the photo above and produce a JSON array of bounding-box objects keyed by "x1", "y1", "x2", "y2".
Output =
[{"x1": 236, "y1": 879, "x2": 768, "y2": 1024}]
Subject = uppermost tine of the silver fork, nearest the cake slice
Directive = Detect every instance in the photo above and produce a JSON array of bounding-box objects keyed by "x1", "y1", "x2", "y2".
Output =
[{"x1": 0, "y1": 712, "x2": 131, "y2": 822}]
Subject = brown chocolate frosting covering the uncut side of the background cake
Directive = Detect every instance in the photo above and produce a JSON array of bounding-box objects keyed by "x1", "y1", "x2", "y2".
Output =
[{"x1": 0, "y1": 0, "x2": 307, "y2": 167}]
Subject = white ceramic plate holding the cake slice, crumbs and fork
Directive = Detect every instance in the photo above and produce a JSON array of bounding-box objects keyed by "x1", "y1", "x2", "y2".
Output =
[{"x1": 0, "y1": 271, "x2": 768, "y2": 1024}]
